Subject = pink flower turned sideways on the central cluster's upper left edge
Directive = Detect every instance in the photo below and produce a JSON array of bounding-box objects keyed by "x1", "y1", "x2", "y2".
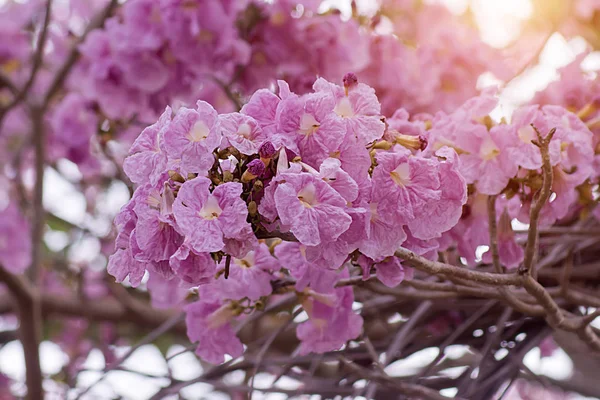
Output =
[{"x1": 123, "y1": 107, "x2": 171, "y2": 185}]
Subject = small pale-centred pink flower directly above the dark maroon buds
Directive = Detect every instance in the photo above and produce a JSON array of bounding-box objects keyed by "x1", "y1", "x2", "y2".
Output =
[{"x1": 217, "y1": 113, "x2": 266, "y2": 155}]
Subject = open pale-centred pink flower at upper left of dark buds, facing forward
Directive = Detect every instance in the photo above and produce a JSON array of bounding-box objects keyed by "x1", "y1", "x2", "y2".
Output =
[{"x1": 164, "y1": 101, "x2": 221, "y2": 174}]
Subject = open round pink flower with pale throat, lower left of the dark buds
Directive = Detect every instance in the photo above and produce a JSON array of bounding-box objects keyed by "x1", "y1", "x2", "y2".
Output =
[{"x1": 173, "y1": 177, "x2": 248, "y2": 253}]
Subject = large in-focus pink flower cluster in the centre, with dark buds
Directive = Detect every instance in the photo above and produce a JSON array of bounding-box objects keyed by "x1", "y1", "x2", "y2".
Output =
[{"x1": 108, "y1": 74, "x2": 467, "y2": 362}]
